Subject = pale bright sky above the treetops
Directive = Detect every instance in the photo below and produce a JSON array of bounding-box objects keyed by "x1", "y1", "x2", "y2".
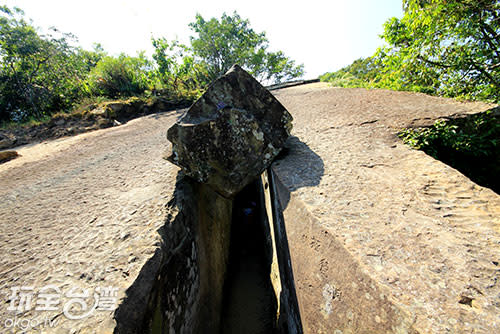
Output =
[{"x1": 2, "y1": 0, "x2": 403, "y2": 78}]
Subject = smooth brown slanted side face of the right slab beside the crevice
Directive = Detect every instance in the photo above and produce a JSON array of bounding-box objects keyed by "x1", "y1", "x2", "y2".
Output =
[{"x1": 270, "y1": 166, "x2": 417, "y2": 334}]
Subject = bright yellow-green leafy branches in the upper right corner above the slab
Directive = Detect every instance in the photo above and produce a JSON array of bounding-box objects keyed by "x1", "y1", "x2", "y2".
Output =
[{"x1": 322, "y1": 0, "x2": 500, "y2": 102}]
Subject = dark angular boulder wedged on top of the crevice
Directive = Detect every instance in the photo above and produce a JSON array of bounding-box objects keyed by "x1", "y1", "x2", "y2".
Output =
[{"x1": 167, "y1": 65, "x2": 292, "y2": 197}]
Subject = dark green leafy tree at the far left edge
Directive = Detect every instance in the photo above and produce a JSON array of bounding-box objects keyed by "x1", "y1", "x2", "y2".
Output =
[{"x1": 0, "y1": 6, "x2": 96, "y2": 120}]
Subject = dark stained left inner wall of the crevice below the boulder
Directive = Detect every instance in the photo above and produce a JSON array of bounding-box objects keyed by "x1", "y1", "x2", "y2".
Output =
[{"x1": 115, "y1": 176, "x2": 232, "y2": 334}]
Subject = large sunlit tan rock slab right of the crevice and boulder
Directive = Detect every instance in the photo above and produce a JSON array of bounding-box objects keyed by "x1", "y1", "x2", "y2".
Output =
[{"x1": 272, "y1": 84, "x2": 500, "y2": 334}]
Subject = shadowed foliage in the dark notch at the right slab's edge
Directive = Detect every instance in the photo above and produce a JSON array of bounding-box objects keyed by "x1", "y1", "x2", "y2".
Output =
[{"x1": 399, "y1": 108, "x2": 500, "y2": 193}]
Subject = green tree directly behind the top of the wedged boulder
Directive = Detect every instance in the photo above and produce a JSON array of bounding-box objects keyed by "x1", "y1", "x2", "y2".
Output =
[{"x1": 189, "y1": 12, "x2": 304, "y2": 82}]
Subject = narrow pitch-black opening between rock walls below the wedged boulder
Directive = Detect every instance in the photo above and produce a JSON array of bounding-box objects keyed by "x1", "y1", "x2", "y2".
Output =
[{"x1": 221, "y1": 180, "x2": 278, "y2": 334}]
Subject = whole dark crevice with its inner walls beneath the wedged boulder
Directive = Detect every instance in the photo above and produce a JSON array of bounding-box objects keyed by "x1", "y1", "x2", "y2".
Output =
[{"x1": 115, "y1": 172, "x2": 303, "y2": 334}]
